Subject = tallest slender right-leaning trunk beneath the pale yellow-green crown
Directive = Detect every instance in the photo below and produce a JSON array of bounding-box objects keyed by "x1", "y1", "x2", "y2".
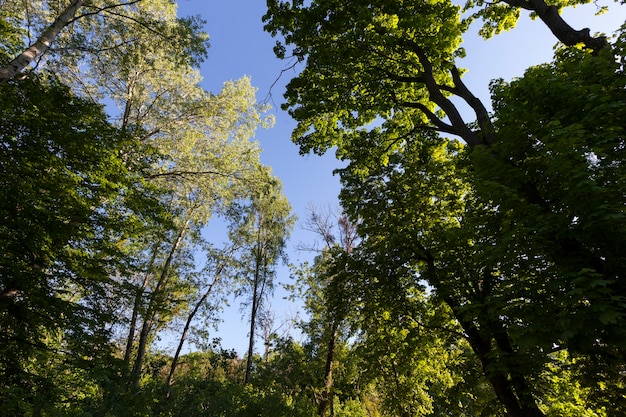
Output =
[{"x1": 132, "y1": 217, "x2": 191, "y2": 389}]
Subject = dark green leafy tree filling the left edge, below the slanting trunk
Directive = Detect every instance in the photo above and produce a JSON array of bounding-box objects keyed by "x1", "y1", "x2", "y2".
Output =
[{"x1": 0, "y1": 75, "x2": 167, "y2": 415}]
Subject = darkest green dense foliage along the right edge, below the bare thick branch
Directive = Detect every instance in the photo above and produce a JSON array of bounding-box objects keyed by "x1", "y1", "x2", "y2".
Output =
[{"x1": 474, "y1": 40, "x2": 626, "y2": 410}]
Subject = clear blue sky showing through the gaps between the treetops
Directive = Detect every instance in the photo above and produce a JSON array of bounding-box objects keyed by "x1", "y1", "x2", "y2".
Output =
[{"x1": 172, "y1": 0, "x2": 626, "y2": 354}]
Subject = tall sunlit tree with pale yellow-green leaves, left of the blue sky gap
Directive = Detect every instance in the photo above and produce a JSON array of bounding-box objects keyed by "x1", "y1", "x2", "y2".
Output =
[{"x1": 15, "y1": 0, "x2": 271, "y2": 389}]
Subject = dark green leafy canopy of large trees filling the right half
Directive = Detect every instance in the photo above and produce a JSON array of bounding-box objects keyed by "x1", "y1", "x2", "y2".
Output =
[{"x1": 265, "y1": 1, "x2": 626, "y2": 417}]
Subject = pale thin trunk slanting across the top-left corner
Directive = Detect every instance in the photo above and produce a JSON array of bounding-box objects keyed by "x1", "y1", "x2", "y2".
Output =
[{"x1": 0, "y1": 0, "x2": 84, "y2": 84}]
